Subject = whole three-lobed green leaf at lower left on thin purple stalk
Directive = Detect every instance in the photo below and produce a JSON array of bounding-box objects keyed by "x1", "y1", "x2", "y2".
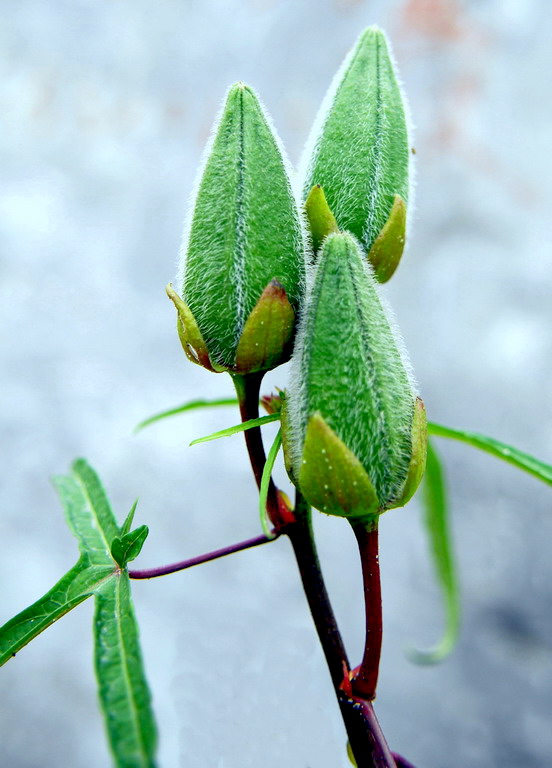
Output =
[{"x1": 0, "y1": 459, "x2": 156, "y2": 768}]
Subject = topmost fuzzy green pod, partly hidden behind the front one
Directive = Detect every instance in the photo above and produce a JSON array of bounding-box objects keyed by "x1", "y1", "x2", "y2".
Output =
[{"x1": 302, "y1": 27, "x2": 411, "y2": 282}]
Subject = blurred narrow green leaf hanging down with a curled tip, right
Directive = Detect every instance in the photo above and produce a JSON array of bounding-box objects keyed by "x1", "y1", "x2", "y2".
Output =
[{"x1": 410, "y1": 441, "x2": 460, "y2": 664}]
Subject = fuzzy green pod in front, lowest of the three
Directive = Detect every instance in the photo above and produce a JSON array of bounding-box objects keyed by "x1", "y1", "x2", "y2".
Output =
[{"x1": 282, "y1": 234, "x2": 427, "y2": 520}]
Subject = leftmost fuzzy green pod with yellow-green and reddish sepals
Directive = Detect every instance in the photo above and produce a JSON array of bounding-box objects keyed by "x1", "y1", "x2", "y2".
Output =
[{"x1": 168, "y1": 83, "x2": 304, "y2": 373}]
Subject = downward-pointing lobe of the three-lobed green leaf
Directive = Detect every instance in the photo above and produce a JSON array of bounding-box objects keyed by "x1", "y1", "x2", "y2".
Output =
[{"x1": 95, "y1": 573, "x2": 157, "y2": 768}]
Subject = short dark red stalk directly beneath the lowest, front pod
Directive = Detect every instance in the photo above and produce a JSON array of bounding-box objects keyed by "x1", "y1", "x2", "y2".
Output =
[{"x1": 352, "y1": 518, "x2": 382, "y2": 701}]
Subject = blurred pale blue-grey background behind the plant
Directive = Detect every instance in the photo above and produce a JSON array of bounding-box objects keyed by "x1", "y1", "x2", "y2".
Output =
[{"x1": 0, "y1": 0, "x2": 552, "y2": 768}]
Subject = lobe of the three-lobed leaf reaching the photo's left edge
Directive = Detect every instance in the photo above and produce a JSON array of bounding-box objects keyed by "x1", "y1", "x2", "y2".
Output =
[{"x1": 0, "y1": 555, "x2": 114, "y2": 666}]
